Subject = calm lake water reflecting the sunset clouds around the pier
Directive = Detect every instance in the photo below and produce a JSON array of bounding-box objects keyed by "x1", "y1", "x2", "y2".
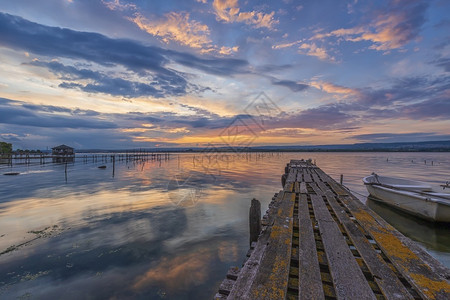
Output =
[{"x1": 0, "y1": 153, "x2": 450, "y2": 299}]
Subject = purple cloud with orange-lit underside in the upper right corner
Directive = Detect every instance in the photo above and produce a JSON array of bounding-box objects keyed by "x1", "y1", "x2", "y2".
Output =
[{"x1": 311, "y1": 0, "x2": 428, "y2": 51}]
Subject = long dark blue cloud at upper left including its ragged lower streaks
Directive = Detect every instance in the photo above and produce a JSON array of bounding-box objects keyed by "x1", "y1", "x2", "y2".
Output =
[{"x1": 0, "y1": 13, "x2": 253, "y2": 97}]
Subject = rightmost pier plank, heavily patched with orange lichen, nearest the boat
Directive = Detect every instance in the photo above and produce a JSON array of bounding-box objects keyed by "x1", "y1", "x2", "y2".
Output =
[{"x1": 338, "y1": 195, "x2": 450, "y2": 299}]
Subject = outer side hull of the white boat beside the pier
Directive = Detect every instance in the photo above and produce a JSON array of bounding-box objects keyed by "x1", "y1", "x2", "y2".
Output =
[{"x1": 366, "y1": 185, "x2": 450, "y2": 222}]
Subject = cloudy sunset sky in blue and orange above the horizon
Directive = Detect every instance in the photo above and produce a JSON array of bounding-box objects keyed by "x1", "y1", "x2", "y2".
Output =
[{"x1": 0, "y1": 0, "x2": 450, "y2": 149}]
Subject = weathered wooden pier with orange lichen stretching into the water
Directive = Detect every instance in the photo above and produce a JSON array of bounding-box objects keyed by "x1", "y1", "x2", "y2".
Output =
[{"x1": 215, "y1": 160, "x2": 450, "y2": 299}]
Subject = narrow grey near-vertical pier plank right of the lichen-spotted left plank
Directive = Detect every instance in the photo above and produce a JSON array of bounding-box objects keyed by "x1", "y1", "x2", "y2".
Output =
[{"x1": 298, "y1": 193, "x2": 325, "y2": 299}]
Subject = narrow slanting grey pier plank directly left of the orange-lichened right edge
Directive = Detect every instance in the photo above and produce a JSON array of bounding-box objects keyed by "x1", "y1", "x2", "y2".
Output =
[{"x1": 326, "y1": 191, "x2": 413, "y2": 299}]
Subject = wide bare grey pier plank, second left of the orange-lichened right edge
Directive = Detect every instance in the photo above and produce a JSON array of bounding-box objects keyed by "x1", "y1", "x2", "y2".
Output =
[{"x1": 311, "y1": 194, "x2": 376, "y2": 299}]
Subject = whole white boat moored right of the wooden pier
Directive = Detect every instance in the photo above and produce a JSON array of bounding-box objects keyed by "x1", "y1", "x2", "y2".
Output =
[{"x1": 363, "y1": 173, "x2": 450, "y2": 222}]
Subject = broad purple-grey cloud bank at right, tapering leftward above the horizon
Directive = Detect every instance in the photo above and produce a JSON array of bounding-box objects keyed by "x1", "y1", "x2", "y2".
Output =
[{"x1": 265, "y1": 72, "x2": 450, "y2": 130}]
